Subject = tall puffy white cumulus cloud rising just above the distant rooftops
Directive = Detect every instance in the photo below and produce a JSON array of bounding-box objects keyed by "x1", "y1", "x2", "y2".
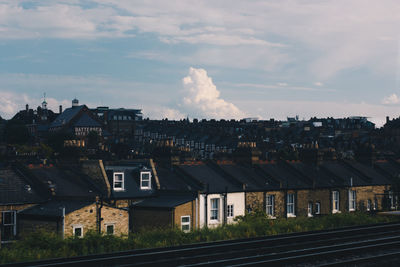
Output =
[{"x1": 182, "y1": 68, "x2": 245, "y2": 119}]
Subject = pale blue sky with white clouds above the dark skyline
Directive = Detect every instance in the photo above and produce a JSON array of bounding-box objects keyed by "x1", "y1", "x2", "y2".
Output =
[{"x1": 0, "y1": 0, "x2": 400, "y2": 126}]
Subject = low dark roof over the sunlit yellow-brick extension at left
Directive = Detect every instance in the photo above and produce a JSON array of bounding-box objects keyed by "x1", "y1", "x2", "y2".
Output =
[{"x1": 18, "y1": 200, "x2": 94, "y2": 217}]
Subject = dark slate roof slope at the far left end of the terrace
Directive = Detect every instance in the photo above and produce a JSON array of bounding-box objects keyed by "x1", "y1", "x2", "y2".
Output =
[{"x1": 0, "y1": 168, "x2": 44, "y2": 205}]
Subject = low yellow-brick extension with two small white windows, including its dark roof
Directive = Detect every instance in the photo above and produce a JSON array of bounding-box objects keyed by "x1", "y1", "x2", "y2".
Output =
[{"x1": 18, "y1": 200, "x2": 129, "y2": 237}]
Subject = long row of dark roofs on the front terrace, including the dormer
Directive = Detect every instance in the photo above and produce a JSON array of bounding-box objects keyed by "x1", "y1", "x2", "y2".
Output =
[{"x1": 0, "y1": 160, "x2": 400, "y2": 205}]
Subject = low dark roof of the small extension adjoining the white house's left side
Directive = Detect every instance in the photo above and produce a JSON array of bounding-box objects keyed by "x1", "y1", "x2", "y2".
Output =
[{"x1": 133, "y1": 194, "x2": 196, "y2": 208}]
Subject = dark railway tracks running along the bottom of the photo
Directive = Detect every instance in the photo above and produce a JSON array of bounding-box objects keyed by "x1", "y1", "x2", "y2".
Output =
[{"x1": 4, "y1": 223, "x2": 400, "y2": 267}]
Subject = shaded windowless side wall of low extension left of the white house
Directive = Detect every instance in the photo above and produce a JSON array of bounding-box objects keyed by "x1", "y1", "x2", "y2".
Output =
[{"x1": 131, "y1": 207, "x2": 174, "y2": 231}]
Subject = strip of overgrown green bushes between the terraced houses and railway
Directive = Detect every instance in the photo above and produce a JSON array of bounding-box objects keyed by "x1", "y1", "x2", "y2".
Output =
[{"x1": 0, "y1": 212, "x2": 398, "y2": 264}]
